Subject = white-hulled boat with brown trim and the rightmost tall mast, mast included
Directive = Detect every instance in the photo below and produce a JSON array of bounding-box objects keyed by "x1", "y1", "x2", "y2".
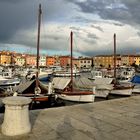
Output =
[{"x1": 109, "y1": 34, "x2": 134, "y2": 96}]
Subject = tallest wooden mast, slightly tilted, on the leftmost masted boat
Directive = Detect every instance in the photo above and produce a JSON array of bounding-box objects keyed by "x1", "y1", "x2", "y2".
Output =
[{"x1": 36, "y1": 4, "x2": 42, "y2": 88}]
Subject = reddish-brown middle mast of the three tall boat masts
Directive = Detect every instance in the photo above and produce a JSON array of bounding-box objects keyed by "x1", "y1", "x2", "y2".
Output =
[{"x1": 70, "y1": 31, "x2": 73, "y2": 91}]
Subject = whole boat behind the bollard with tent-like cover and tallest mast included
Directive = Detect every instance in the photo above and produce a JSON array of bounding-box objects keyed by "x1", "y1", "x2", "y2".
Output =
[{"x1": 13, "y1": 4, "x2": 56, "y2": 105}]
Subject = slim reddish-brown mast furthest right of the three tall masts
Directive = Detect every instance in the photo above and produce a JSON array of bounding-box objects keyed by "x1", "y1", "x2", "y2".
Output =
[{"x1": 114, "y1": 33, "x2": 117, "y2": 87}]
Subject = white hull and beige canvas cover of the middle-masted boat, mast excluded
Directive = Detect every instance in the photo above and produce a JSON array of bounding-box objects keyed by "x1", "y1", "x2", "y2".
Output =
[{"x1": 52, "y1": 77, "x2": 95, "y2": 102}]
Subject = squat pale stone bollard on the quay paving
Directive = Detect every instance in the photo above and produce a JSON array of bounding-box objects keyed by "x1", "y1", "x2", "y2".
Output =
[{"x1": 1, "y1": 96, "x2": 31, "y2": 136}]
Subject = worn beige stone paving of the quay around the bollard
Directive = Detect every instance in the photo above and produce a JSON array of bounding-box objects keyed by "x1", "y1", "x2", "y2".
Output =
[{"x1": 0, "y1": 96, "x2": 140, "y2": 140}]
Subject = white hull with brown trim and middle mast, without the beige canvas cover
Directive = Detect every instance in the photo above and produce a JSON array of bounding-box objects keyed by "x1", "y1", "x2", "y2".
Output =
[{"x1": 55, "y1": 32, "x2": 95, "y2": 102}]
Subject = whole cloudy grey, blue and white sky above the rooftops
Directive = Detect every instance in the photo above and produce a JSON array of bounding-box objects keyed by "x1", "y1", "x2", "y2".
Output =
[{"x1": 0, "y1": 0, "x2": 140, "y2": 56}]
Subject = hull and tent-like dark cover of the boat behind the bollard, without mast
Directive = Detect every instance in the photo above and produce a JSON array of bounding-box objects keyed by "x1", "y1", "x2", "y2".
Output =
[{"x1": 13, "y1": 79, "x2": 56, "y2": 102}]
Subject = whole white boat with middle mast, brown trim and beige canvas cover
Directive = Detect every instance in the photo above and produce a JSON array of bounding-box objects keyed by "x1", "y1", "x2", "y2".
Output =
[{"x1": 53, "y1": 32, "x2": 95, "y2": 102}]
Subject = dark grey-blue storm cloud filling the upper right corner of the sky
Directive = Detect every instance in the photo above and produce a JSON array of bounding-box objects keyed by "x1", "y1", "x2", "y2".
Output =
[{"x1": 68, "y1": 0, "x2": 140, "y2": 24}]
